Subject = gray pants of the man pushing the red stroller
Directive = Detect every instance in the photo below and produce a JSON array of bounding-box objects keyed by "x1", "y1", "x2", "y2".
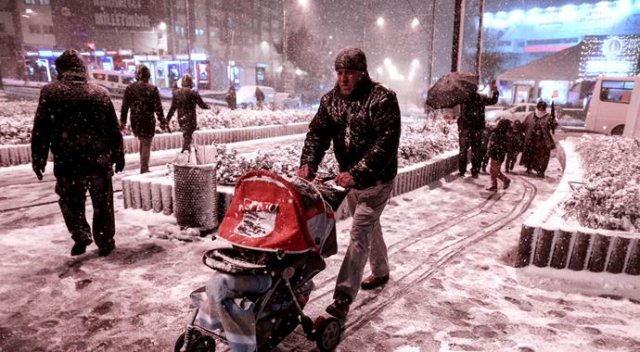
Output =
[{"x1": 333, "y1": 180, "x2": 393, "y2": 302}]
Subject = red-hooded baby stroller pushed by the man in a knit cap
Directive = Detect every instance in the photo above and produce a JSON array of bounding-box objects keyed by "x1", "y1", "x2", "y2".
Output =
[{"x1": 175, "y1": 170, "x2": 346, "y2": 352}]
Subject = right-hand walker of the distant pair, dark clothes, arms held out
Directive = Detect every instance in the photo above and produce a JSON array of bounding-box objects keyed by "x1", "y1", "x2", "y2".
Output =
[{"x1": 167, "y1": 74, "x2": 210, "y2": 151}]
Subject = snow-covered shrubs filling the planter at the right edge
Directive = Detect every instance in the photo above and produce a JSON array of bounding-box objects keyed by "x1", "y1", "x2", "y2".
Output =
[{"x1": 564, "y1": 135, "x2": 640, "y2": 232}]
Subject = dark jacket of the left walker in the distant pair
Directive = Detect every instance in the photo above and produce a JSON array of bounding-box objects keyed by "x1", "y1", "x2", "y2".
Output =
[{"x1": 120, "y1": 81, "x2": 165, "y2": 138}]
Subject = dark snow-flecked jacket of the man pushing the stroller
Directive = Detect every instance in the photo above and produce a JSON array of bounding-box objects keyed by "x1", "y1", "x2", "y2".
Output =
[{"x1": 300, "y1": 78, "x2": 400, "y2": 189}]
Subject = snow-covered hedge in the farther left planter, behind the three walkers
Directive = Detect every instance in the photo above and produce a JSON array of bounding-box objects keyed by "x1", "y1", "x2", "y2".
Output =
[{"x1": 0, "y1": 101, "x2": 314, "y2": 144}]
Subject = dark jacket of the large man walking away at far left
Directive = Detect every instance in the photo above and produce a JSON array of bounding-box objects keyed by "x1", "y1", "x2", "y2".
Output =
[{"x1": 31, "y1": 71, "x2": 124, "y2": 177}]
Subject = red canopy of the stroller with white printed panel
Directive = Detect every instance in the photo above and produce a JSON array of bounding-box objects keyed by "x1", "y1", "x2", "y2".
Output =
[{"x1": 218, "y1": 170, "x2": 335, "y2": 255}]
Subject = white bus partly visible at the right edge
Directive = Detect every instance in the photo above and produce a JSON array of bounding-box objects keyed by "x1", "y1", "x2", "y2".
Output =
[{"x1": 585, "y1": 76, "x2": 640, "y2": 135}]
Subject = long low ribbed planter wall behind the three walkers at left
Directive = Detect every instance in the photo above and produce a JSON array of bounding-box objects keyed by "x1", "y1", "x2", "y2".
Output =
[{"x1": 0, "y1": 122, "x2": 309, "y2": 166}]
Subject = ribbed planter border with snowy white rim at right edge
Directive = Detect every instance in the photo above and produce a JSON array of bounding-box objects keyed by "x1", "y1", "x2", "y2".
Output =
[{"x1": 515, "y1": 139, "x2": 640, "y2": 277}]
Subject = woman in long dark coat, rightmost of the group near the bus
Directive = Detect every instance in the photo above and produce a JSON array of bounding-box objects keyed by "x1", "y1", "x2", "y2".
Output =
[{"x1": 521, "y1": 101, "x2": 556, "y2": 177}]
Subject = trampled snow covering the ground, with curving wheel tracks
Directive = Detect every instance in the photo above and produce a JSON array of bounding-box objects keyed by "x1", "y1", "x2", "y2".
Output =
[{"x1": 0, "y1": 155, "x2": 640, "y2": 352}]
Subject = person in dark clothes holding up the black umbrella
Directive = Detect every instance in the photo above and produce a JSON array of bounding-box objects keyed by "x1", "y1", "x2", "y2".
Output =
[{"x1": 458, "y1": 82, "x2": 499, "y2": 178}]
